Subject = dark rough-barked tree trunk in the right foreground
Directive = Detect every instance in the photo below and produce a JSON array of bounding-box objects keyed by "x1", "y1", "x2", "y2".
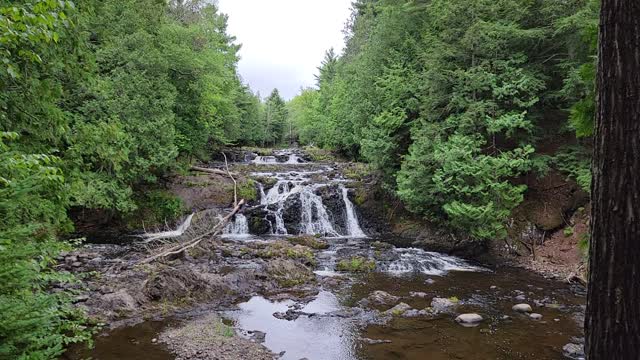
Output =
[{"x1": 585, "y1": 0, "x2": 640, "y2": 360}]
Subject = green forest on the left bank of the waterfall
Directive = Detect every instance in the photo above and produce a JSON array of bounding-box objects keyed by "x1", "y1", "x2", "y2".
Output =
[{"x1": 0, "y1": 0, "x2": 286, "y2": 359}]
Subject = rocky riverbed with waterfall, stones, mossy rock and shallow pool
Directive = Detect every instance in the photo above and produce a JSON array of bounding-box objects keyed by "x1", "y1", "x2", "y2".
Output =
[{"x1": 60, "y1": 151, "x2": 584, "y2": 360}]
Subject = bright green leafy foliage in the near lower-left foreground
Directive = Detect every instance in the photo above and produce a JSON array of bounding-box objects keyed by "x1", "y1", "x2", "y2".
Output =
[{"x1": 0, "y1": 132, "x2": 91, "y2": 359}]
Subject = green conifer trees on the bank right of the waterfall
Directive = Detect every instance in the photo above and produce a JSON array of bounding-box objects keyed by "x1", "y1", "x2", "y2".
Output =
[{"x1": 290, "y1": 0, "x2": 597, "y2": 239}]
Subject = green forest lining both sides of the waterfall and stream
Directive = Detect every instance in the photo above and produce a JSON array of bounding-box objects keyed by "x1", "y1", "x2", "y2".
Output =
[{"x1": 0, "y1": 0, "x2": 636, "y2": 359}]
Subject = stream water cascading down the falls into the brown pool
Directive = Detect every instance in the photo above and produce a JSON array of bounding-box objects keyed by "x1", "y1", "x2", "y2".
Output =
[{"x1": 70, "y1": 150, "x2": 585, "y2": 360}]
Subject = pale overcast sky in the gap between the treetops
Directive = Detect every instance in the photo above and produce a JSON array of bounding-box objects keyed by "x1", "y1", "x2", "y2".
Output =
[{"x1": 218, "y1": 0, "x2": 351, "y2": 99}]
